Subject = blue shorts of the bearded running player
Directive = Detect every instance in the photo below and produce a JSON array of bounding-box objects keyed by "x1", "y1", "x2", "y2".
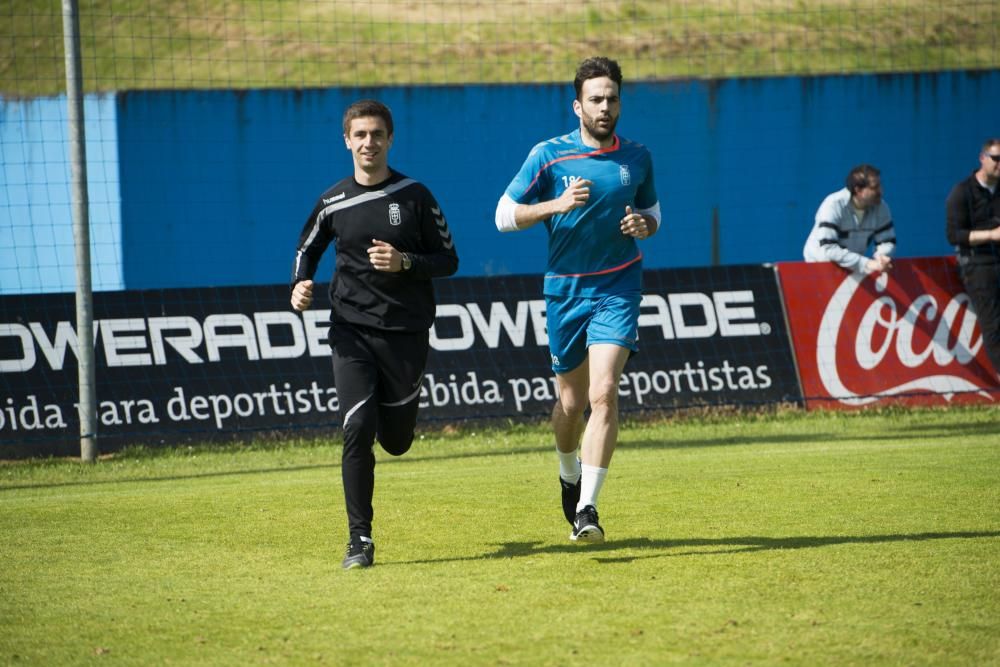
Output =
[{"x1": 545, "y1": 292, "x2": 642, "y2": 373}]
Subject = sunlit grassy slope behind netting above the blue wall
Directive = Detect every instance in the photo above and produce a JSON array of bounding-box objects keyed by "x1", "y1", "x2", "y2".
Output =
[{"x1": 0, "y1": 0, "x2": 1000, "y2": 96}]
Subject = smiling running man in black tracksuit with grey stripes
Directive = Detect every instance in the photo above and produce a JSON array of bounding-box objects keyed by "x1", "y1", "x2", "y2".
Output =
[{"x1": 291, "y1": 100, "x2": 458, "y2": 569}]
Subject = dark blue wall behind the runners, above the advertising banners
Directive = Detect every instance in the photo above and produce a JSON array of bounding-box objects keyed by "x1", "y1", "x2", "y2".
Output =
[{"x1": 0, "y1": 71, "x2": 1000, "y2": 291}]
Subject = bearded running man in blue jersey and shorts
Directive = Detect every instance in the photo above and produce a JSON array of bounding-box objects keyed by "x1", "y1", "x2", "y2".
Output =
[{"x1": 496, "y1": 58, "x2": 660, "y2": 543}]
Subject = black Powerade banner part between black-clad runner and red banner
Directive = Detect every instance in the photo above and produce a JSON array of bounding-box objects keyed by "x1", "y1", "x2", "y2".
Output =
[{"x1": 424, "y1": 265, "x2": 800, "y2": 418}]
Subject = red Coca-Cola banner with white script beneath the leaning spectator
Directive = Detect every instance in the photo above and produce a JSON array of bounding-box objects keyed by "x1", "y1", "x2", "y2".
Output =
[{"x1": 778, "y1": 257, "x2": 1000, "y2": 408}]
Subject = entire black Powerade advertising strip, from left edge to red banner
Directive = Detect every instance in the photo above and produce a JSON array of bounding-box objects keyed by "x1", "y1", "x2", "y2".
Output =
[{"x1": 0, "y1": 266, "x2": 800, "y2": 456}]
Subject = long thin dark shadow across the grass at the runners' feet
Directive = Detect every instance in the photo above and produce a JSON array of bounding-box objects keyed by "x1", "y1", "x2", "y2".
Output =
[{"x1": 384, "y1": 531, "x2": 1000, "y2": 565}]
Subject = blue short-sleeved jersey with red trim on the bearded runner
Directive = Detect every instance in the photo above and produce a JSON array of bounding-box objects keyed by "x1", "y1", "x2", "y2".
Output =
[{"x1": 506, "y1": 129, "x2": 657, "y2": 296}]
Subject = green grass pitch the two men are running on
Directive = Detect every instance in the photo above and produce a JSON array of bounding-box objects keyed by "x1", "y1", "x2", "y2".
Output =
[{"x1": 0, "y1": 408, "x2": 1000, "y2": 665}]
